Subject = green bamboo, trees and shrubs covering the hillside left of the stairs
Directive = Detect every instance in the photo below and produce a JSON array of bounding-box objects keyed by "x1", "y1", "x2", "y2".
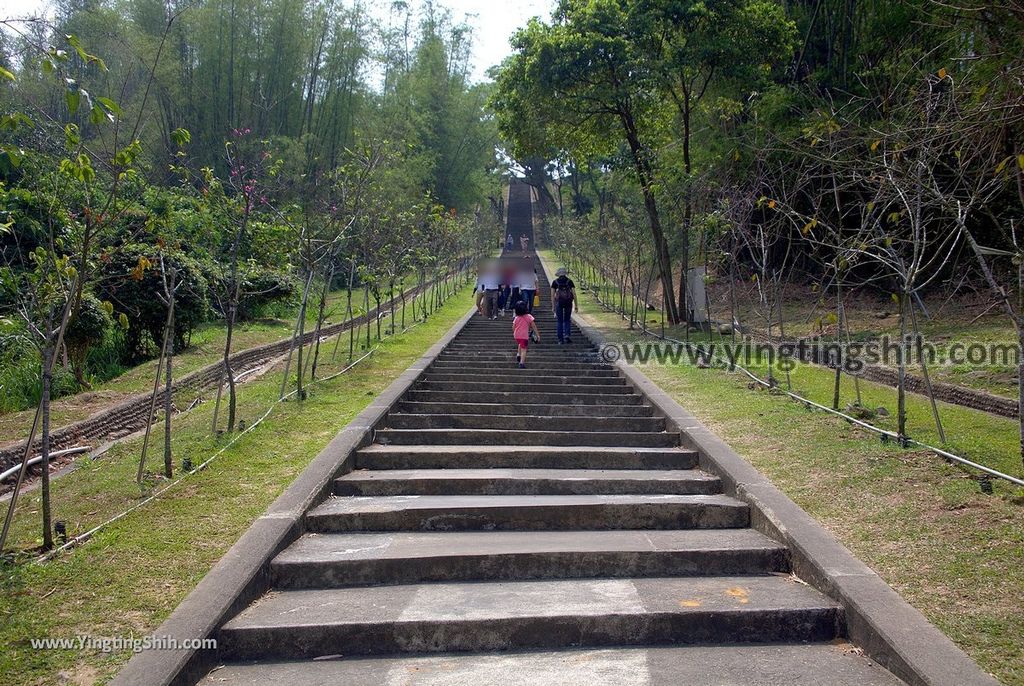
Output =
[{"x1": 0, "y1": 0, "x2": 502, "y2": 549}]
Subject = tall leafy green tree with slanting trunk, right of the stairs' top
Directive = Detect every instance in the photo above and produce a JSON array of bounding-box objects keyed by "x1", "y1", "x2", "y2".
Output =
[{"x1": 493, "y1": 0, "x2": 681, "y2": 323}]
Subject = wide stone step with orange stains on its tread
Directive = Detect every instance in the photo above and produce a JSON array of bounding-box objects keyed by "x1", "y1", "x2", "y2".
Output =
[{"x1": 218, "y1": 575, "x2": 842, "y2": 663}]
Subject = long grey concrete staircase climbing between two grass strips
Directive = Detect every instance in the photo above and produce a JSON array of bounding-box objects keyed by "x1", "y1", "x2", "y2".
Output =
[{"x1": 195, "y1": 186, "x2": 898, "y2": 686}]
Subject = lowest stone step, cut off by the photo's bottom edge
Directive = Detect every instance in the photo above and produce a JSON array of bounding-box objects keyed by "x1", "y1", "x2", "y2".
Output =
[{"x1": 200, "y1": 641, "x2": 902, "y2": 686}]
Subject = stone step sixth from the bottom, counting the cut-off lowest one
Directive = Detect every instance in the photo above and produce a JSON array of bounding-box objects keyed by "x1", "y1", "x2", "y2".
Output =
[{"x1": 355, "y1": 444, "x2": 697, "y2": 469}]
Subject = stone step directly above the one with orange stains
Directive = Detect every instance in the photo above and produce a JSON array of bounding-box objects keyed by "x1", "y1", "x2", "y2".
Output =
[{"x1": 270, "y1": 528, "x2": 790, "y2": 590}]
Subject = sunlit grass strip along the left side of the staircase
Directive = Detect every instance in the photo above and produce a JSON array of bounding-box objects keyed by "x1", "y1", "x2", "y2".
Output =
[{"x1": 0, "y1": 280, "x2": 471, "y2": 684}]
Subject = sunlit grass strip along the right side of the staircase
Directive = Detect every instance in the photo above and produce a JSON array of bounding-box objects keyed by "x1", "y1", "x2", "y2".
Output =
[{"x1": 544, "y1": 252, "x2": 1024, "y2": 684}]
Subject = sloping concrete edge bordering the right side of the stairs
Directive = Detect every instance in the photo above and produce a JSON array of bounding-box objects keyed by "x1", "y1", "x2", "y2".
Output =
[{"x1": 572, "y1": 314, "x2": 998, "y2": 686}]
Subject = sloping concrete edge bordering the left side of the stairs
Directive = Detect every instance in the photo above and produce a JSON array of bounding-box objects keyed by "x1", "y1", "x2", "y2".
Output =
[{"x1": 111, "y1": 308, "x2": 476, "y2": 686}]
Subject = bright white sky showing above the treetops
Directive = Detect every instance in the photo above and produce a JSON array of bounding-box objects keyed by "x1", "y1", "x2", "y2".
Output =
[{"x1": 0, "y1": 0, "x2": 555, "y2": 81}]
